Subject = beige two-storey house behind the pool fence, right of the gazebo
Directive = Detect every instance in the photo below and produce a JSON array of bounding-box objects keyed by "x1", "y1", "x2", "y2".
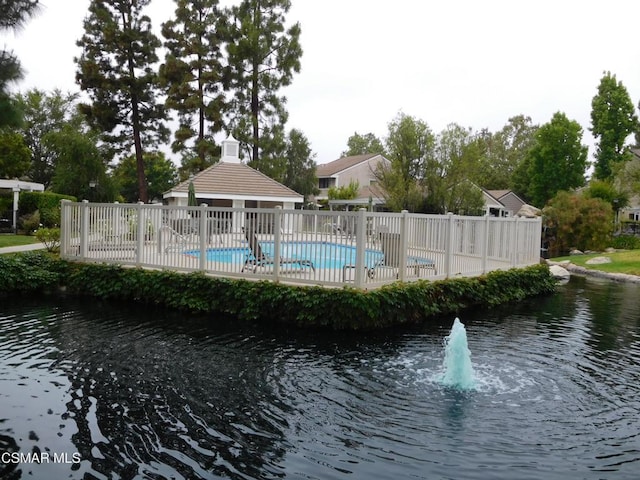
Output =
[{"x1": 315, "y1": 153, "x2": 390, "y2": 209}]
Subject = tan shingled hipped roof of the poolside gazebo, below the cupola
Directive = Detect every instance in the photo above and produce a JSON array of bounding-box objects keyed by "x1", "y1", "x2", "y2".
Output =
[{"x1": 164, "y1": 162, "x2": 303, "y2": 202}]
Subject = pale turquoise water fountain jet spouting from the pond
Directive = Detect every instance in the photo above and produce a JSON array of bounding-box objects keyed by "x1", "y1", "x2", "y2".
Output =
[{"x1": 440, "y1": 318, "x2": 475, "y2": 390}]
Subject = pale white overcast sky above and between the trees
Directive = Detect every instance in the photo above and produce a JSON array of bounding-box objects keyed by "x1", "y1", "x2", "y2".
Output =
[{"x1": 0, "y1": 0, "x2": 640, "y2": 163}]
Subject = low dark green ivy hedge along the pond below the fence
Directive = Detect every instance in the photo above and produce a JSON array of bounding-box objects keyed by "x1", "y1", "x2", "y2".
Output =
[{"x1": 0, "y1": 253, "x2": 556, "y2": 330}]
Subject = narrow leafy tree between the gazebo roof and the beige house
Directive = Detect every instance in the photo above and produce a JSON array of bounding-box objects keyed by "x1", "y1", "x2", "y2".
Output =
[{"x1": 282, "y1": 129, "x2": 319, "y2": 201}]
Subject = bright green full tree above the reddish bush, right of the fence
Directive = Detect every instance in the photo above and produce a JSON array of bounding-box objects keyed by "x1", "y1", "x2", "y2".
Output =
[{"x1": 528, "y1": 112, "x2": 588, "y2": 207}]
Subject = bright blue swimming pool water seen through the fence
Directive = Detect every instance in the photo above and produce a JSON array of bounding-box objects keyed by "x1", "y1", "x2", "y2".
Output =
[{"x1": 185, "y1": 242, "x2": 384, "y2": 268}]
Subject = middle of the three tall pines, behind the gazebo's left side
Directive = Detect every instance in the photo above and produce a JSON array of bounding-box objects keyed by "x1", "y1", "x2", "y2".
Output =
[{"x1": 160, "y1": 0, "x2": 227, "y2": 171}]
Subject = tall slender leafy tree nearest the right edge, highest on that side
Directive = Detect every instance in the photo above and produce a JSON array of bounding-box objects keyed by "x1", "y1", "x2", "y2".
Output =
[{"x1": 591, "y1": 72, "x2": 640, "y2": 180}]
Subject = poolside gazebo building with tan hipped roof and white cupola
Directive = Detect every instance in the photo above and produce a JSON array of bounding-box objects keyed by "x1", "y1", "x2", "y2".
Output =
[{"x1": 163, "y1": 137, "x2": 304, "y2": 209}]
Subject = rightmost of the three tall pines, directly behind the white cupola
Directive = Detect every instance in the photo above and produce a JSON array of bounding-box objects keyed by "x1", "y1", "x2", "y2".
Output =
[{"x1": 228, "y1": 0, "x2": 302, "y2": 174}]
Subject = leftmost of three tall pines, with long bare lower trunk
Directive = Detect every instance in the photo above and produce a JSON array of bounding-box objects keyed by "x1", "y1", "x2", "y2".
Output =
[{"x1": 76, "y1": 0, "x2": 169, "y2": 202}]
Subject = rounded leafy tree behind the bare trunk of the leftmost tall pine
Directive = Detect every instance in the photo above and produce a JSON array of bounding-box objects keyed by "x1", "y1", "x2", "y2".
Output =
[{"x1": 113, "y1": 152, "x2": 178, "y2": 202}]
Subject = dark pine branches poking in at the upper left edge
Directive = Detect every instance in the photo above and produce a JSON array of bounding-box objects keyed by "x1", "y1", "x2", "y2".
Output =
[{"x1": 0, "y1": 0, "x2": 39, "y2": 128}]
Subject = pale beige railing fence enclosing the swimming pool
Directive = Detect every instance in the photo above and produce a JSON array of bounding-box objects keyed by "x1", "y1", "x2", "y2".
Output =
[{"x1": 61, "y1": 201, "x2": 541, "y2": 288}]
